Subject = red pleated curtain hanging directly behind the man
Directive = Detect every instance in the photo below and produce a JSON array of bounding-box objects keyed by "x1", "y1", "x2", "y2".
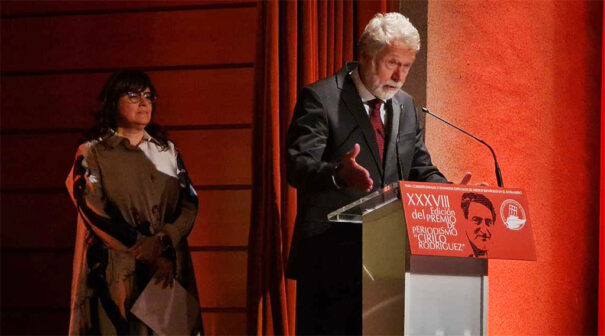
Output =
[{"x1": 247, "y1": 0, "x2": 396, "y2": 335}]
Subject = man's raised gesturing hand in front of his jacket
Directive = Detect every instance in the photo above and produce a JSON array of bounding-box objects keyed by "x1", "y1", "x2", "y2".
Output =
[{"x1": 336, "y1": 144, "x2": 374, "y2": 192}]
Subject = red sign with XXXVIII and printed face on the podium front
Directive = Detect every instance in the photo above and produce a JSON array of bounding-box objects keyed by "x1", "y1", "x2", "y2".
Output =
[{"x1": 400, "y1": 181, "x2": 536, "y2": 260}]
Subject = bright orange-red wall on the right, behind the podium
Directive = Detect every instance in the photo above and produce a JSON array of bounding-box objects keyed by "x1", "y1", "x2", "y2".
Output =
[{"x1": 427, "y1": 0, "x2": 602, "y2": 335}]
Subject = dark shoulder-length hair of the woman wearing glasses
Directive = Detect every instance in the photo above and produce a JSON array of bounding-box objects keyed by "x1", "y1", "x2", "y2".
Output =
[{"x1": 82, "y1": 69, "x2": 168, "y2": 146}]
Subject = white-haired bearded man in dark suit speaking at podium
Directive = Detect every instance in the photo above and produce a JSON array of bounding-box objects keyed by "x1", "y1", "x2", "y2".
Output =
[{"x1": 286, "y1": 13, "x2": 447, "y2": 335}]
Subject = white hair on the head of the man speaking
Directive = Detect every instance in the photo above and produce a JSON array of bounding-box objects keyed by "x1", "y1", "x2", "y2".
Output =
[{"x1": 358, "y1": 13, "x2": 420, "y2": 57}]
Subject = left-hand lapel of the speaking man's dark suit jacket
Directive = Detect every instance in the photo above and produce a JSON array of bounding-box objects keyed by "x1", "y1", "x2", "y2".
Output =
[{"x1": 337, "y1": 64, "x2": 383, "y2": 175}]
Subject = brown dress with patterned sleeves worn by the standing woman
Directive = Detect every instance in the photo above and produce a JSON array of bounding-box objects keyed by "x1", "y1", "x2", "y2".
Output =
[{"x1": 66, "y1": 134, "x2": 202, "y2": 335}]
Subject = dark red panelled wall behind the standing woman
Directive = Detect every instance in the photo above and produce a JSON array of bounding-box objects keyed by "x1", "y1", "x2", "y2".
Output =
[{"x1": 0, "y1": 0, "x2": 257, "y2": 335}]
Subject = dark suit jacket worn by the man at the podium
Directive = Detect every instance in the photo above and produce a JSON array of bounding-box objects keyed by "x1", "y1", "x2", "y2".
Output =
[{"x1": 286, "y1": 63, "x2": 446, "y2": 279}]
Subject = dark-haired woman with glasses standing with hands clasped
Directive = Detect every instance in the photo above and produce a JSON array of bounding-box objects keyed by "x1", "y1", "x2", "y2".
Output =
[{"x1": 67, "y1": 70, "x2": 203, "y2": 335}]
